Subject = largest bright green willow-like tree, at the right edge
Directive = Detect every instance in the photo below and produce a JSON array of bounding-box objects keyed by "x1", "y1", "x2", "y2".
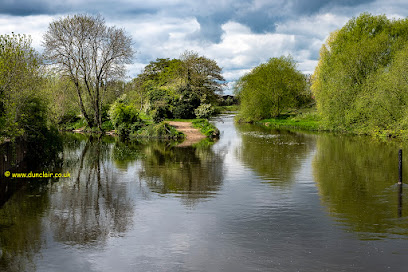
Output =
[{"x1": 312, "y1": 13, "x2": 408, "y2": 133}]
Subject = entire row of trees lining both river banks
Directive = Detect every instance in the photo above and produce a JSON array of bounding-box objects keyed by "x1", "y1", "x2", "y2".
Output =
[{"x1": 0, "y1": 13, "x2": 408, "y2": 138}]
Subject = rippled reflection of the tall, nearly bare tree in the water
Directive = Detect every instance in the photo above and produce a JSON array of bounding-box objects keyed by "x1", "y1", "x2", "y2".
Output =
[{"x1": 51, "y1": 137, "x2": 133, "y2": 244}]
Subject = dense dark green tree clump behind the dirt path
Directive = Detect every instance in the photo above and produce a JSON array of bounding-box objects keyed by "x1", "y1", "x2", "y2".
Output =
[{"x1": 128, "y1": 52, "x2": 225, "y2": 119}]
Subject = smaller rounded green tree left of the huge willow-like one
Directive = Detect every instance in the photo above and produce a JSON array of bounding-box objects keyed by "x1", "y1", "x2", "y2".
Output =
[{"x1": 235, "y1": 56, "x2": 306, "y2": 121}]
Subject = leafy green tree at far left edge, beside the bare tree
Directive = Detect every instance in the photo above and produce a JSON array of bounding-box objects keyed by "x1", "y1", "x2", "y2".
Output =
[{"x1": 0, "y1": 33, "x2": 46, "y2": 137}]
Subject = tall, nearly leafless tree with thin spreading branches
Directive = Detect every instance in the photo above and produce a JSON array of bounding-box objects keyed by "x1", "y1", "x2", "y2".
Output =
[{"x1": 43, "y1": 15, "x2": 133, "y2": 130}]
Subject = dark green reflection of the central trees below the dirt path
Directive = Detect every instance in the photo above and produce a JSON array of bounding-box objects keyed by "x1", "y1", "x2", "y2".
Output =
[{"x1": 140, "y1": 142, "x2": 223, "y2": 205}]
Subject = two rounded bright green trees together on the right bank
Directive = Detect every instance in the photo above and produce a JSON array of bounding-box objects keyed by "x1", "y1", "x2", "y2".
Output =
[{"x1": 235, "y1": 13, "x2": 408, "y2": 135}]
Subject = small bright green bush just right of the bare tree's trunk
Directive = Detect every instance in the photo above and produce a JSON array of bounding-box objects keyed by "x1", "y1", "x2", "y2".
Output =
[{"x1": 109, "y1": 96, "x2": 144, "y2": 137}]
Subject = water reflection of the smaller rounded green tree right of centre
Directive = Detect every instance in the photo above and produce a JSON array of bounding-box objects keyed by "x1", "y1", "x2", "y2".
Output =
[{"x1": 236, "y1": 125, "x2": 315, "y2": 186}]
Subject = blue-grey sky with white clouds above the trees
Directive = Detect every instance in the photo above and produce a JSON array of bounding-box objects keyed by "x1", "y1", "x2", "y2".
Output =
[{"x1": 0, "y1": 0, "x2": 408, "y2": 93}]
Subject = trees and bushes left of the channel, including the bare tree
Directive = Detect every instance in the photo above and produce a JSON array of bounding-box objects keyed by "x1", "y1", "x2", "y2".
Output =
[{"x1": 0, "y1": 15, "x2": 225, "y2": 139}]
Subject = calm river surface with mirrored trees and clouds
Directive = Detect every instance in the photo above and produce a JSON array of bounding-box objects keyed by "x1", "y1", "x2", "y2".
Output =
[{"x1": 0, "y1": 115, "x2": 408, "y2": 271}]
